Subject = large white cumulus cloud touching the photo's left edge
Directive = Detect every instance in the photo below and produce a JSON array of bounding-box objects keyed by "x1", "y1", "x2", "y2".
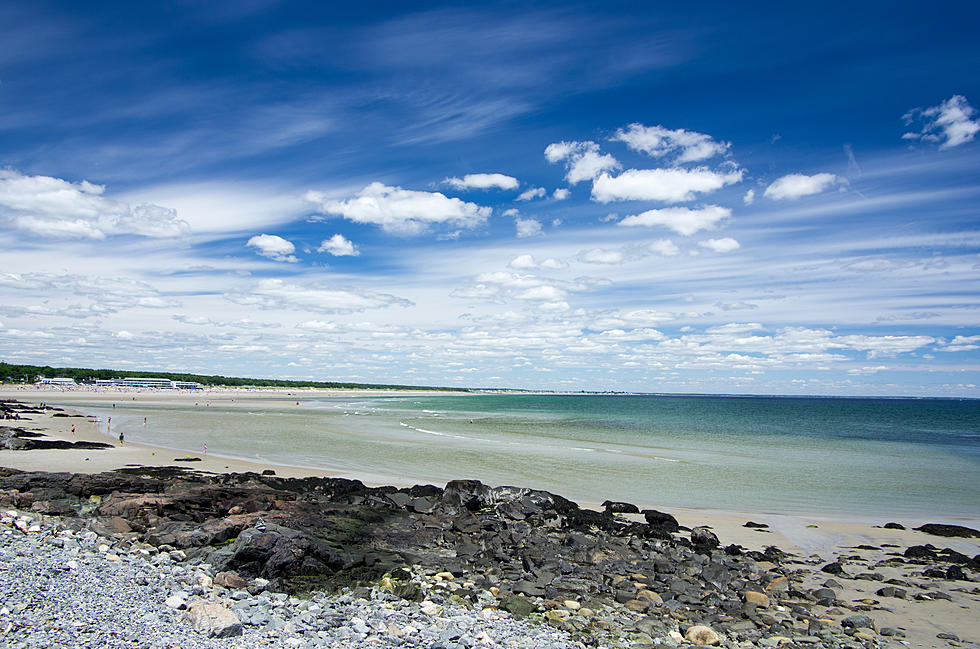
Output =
[{"x1": 0, "y1": 169, "x2": 190, "y2": 240}]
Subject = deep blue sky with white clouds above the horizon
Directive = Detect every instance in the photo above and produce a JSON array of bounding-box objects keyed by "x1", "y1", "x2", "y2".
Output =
[{"x1": 0, "y1": 0, "x2": 980, "y2": 397}]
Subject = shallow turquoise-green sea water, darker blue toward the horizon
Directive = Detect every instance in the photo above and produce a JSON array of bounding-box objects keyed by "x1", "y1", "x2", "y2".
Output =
[{"x1": 65, "y1": 395, "x2": 980, "y2": 520}]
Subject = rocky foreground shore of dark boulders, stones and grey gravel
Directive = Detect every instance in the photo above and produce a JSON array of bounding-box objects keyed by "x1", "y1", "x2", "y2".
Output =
[{"x1": 0, "y1": 460, "x2": 980, "y2": 649}]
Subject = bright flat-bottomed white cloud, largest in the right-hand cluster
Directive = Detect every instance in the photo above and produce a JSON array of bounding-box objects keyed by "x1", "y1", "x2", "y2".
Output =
[{"x1": 592, "y1": 167, "x2": 744, "y2": 203}]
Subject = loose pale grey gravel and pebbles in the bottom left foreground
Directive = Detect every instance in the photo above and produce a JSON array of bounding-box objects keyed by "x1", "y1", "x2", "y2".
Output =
[{"x1": 0, "y1": 511, "x2": 583, "y2": 649}]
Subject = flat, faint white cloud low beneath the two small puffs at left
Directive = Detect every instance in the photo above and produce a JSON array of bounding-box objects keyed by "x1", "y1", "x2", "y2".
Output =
[{"x1": 225, "y1": 279, "x2": 412, "y2": 313}]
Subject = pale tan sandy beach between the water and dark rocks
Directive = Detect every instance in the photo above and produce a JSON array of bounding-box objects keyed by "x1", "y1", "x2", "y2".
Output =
[{"x1": 0, "y1": 386, "x2": 980, "y2": 647}]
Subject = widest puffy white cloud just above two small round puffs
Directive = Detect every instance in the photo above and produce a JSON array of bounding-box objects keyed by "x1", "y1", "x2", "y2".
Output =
[{"x1": 306, "y1": 182, "x2": 492, "y2": 234}]
